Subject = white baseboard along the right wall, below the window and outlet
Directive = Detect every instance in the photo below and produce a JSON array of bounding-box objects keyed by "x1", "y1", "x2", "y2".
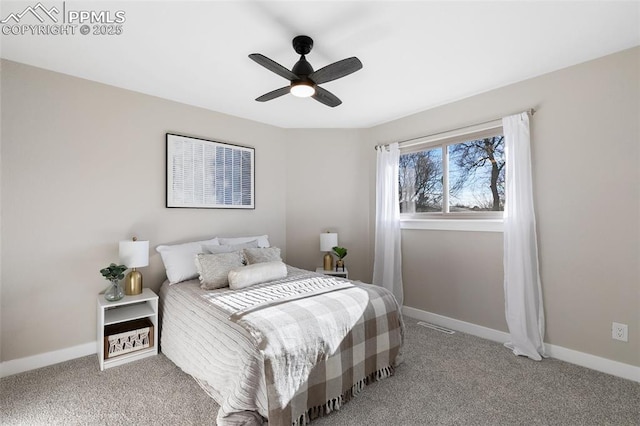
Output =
[{"x1": 402, "y1": 306, "x2": 640, "y2": 382}]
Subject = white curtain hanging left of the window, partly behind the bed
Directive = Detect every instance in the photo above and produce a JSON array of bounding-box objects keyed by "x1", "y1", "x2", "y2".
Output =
[{"x1": 373, "y1": 143, "x2": 403, "y2": 306}]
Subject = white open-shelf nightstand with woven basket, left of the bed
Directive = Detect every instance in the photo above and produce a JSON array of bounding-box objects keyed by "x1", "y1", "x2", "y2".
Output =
[{"x1": 96, "y1": 288, "x2": 158, "y2": 370}]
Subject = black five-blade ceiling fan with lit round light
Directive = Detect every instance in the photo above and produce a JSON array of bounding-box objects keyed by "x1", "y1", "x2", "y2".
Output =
[{"x1": 249, "y1": 35, "x2": 362, "y2": 107}]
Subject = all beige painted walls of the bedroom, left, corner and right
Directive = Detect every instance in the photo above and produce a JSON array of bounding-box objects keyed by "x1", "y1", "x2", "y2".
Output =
[{"x1": 0, "y1": 48, "x2": 640, "y2": 365}]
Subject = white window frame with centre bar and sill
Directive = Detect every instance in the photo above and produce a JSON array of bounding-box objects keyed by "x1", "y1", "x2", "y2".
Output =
[{"x1": 400, "y1": 120, "x2": 504, "y2": 232}]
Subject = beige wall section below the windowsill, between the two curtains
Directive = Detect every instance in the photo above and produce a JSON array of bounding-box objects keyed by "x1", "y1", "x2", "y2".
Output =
[{"x1": 402, "y1": 230, "x2": 508, "y2": 331}]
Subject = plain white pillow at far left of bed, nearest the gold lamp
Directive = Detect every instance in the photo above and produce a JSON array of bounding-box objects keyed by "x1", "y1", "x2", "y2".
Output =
[{"x1": 156, "y1": 238, "x2": 220, "y2": 284}]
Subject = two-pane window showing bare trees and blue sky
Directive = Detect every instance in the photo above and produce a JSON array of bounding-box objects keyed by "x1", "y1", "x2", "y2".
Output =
[{"x1": 399, "y1": 127, "x2": 505, "y2": 219}]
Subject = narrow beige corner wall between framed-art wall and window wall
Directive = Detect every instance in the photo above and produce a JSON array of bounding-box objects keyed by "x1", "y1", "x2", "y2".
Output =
[{"x1": 287, "y1": 129, "x2": 371, "y2": 282}]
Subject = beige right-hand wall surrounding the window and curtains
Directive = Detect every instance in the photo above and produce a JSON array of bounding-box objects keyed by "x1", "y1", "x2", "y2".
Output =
[{"x1": 367, "y1": 48, "x2": 640, "y2": 365}]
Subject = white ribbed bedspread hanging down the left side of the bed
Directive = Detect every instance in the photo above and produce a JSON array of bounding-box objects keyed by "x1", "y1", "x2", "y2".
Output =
[{"x1": 160, "y1": 279, "x2": 268, "y2": 425}]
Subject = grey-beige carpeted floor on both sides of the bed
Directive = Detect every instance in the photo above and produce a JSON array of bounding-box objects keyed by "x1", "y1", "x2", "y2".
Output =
[{"x1": 0, "y1": 318, "x2": 640, "y2": 426}]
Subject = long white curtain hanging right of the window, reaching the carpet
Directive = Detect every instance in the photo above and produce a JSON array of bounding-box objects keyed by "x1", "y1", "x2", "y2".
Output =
[{"x1": 502, "y1": 112, "x2": 546, "y2": 361}]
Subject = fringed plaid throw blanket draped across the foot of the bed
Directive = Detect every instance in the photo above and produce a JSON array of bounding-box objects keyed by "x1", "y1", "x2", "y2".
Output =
[{"x1": 210, "y1": 275, "x2": 404, "y2": 426}]
